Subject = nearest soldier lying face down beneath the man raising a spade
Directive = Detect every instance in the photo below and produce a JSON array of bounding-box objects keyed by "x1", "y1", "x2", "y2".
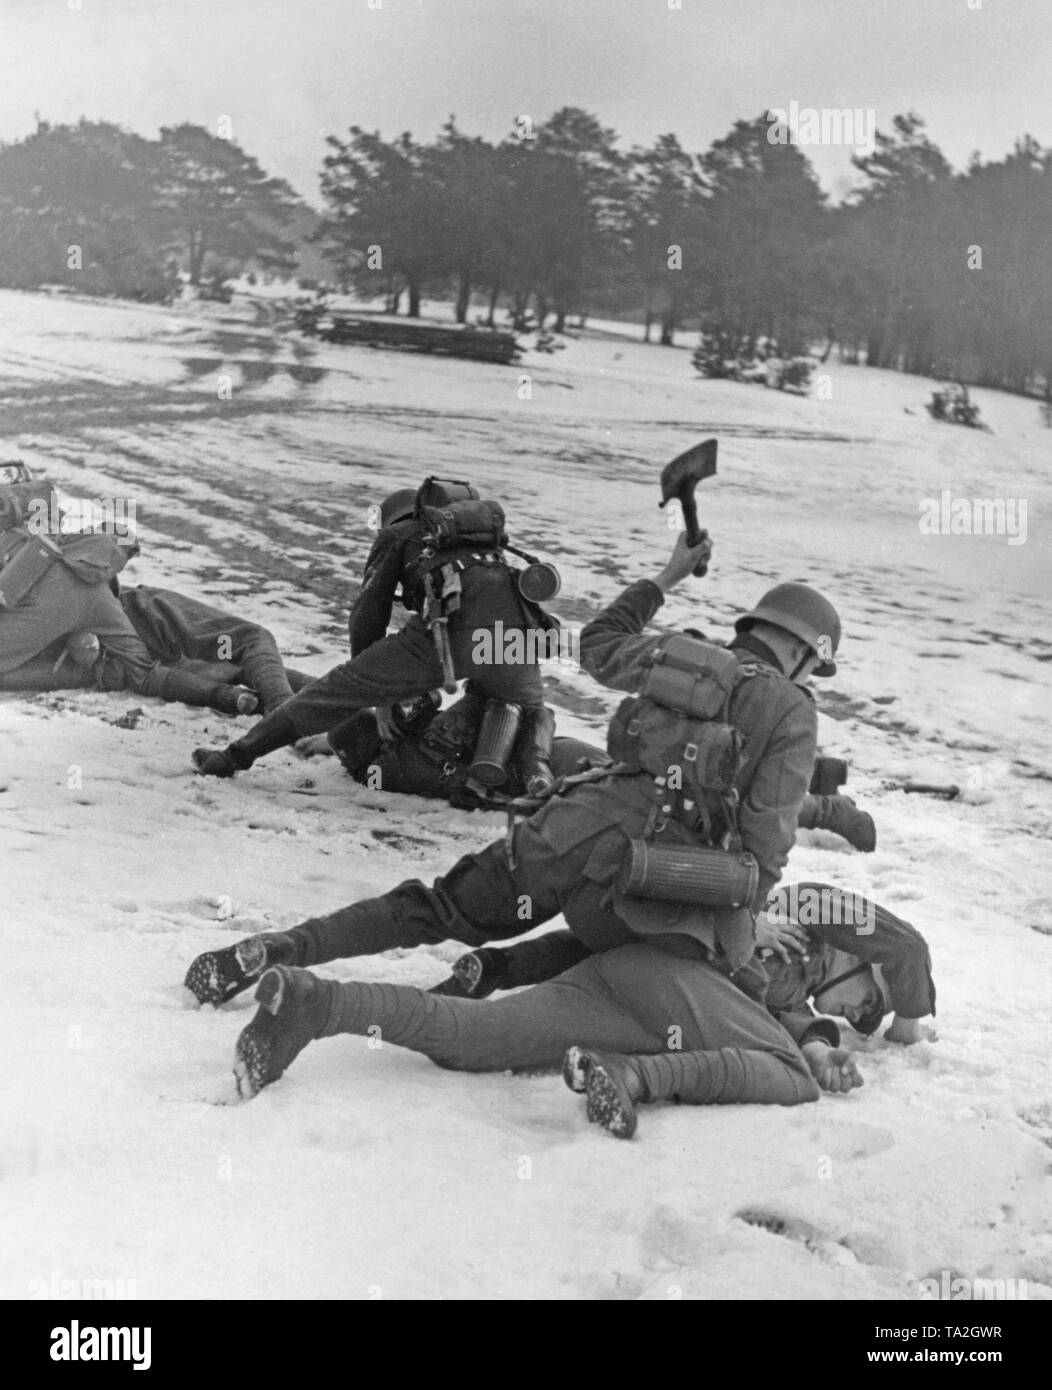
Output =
[{"x1": 223, "y1": 883, "x2": 935, "y2": 1138}]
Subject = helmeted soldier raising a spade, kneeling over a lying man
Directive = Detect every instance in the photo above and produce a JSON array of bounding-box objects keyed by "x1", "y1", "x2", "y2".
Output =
[{"x1": 186, "y1": 535, "x2": 841, "y2": 1045}]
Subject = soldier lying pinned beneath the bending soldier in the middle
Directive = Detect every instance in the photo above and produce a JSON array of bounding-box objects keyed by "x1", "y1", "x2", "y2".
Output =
[{"x1": 328, "y1": 681, "x2": 877, "y2": 850}]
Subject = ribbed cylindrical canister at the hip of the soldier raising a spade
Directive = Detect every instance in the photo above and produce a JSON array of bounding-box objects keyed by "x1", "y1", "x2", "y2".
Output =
[{"x1": 620, "y1": 840, "x2": 760, "y2": 908}]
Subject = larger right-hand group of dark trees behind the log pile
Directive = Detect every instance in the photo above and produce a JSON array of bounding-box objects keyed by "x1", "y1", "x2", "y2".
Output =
[{"x1": 320, "y1": 107, "x2": 1052, "y2": 391}]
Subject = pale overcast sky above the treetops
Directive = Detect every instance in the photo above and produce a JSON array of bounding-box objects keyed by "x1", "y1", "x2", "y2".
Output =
[{"x1": 0, "y1": 0, "x2": 1052, "y2": 202}]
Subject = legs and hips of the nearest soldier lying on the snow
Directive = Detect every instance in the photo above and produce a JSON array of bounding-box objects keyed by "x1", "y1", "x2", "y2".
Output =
[{"x1": 225, "y1": 941, "x2": 863, "y2": 1138}]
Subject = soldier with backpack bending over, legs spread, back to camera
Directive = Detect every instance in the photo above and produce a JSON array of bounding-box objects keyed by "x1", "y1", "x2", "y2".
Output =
[{"x1": 193, "y1": 480, "x2": 557, "y2": 784}]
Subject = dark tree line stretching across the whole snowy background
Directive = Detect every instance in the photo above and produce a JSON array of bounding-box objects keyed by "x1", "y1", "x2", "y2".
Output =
[{"x1": 0, "y1": 107, "x2": 1052, "y2": 392}]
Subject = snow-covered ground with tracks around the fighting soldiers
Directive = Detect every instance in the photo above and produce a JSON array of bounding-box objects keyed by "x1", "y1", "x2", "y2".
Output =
[{"x1": 0, "y1": 293, "x2": 1052, "y2": 1300}]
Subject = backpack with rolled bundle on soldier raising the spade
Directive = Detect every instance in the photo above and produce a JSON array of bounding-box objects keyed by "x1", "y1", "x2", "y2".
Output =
[{"x1": 606, "y1": 632, "x2": 755, "y2": 833}]
